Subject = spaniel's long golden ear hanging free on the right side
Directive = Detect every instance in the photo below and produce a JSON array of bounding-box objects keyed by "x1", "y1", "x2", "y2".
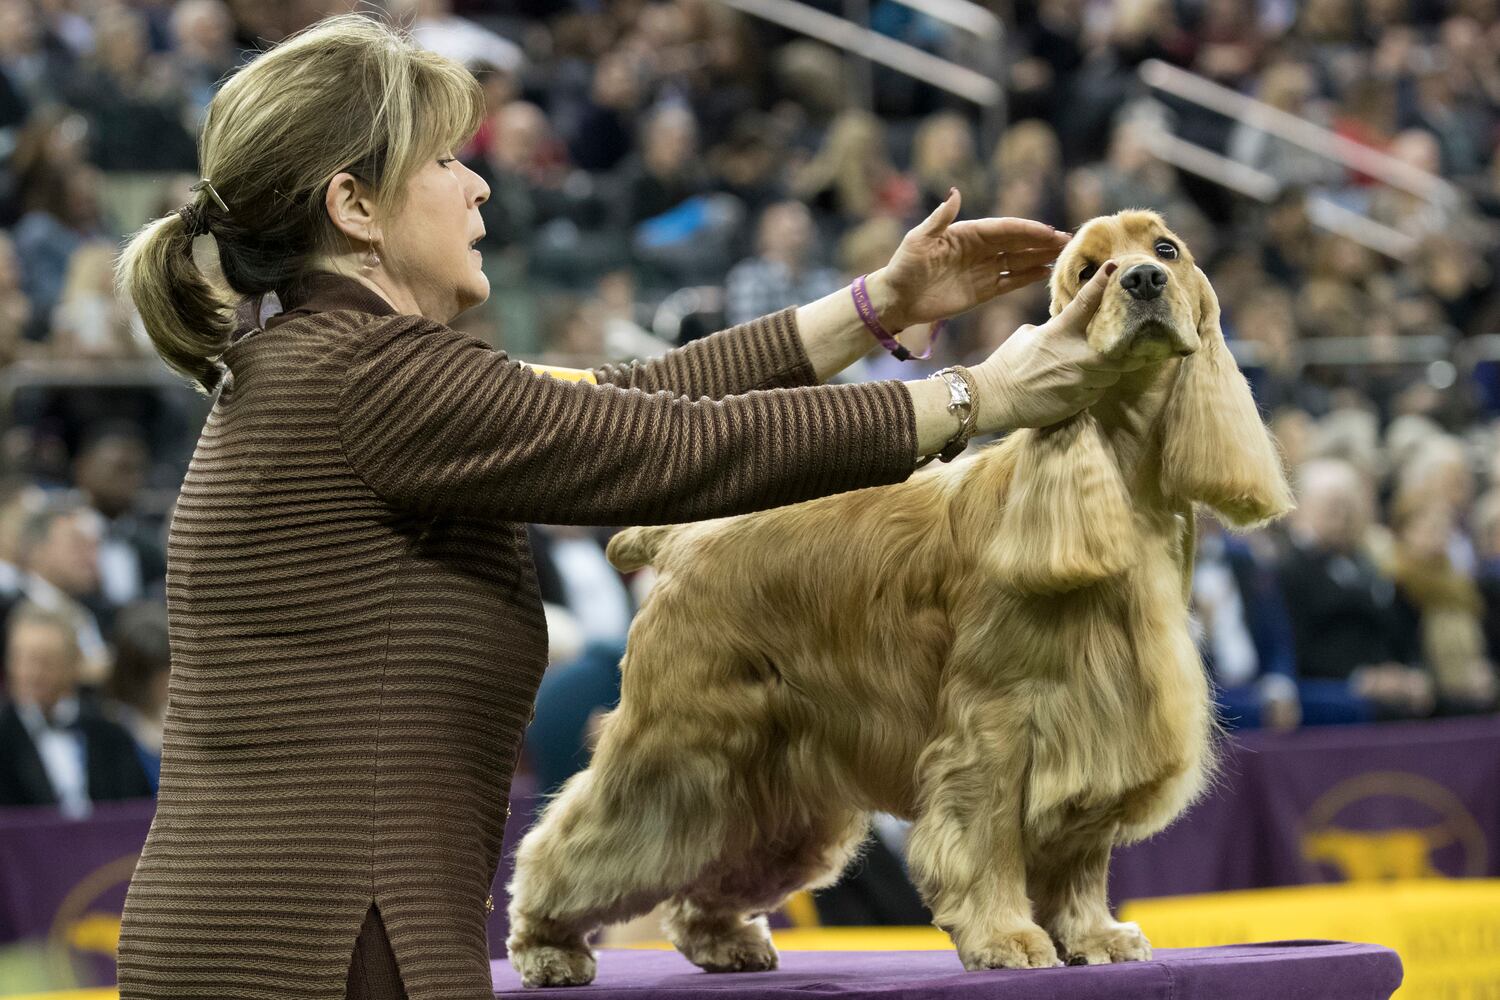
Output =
[{"x1": 1161, "y1": 268, "x2": 1292, "y2": 528}]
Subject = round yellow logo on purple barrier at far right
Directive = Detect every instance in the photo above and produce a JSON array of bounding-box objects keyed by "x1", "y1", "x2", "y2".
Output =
[{"x1": 1302, "y1": 771, "x2": 1488, "y2": 882}]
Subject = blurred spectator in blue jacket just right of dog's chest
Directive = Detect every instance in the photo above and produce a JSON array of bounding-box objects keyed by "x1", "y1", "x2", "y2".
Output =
[{"x1": 1193, "y1": 517, "x2": 1302, "y2": 730}]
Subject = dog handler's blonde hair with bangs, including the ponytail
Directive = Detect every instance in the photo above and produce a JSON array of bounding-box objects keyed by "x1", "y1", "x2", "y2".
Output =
[{"x1": 116, "y1": 13, "x2": 485, "y2": 394}]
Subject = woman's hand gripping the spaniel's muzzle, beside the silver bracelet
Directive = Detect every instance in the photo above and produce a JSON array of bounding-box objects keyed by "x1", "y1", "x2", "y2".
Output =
[{"x1": 972, "y1": 261, "x2": 1143, "y2": 433}]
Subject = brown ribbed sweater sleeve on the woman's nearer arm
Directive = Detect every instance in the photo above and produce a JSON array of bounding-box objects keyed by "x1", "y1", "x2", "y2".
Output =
[{"x1": 338, "y1": 316, "x2": 917, "y2": 525}]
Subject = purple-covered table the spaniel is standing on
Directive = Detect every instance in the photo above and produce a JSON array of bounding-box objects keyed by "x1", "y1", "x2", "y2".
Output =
[{"x1": 492, "y1": 942, "x2": 1401, "y2": 1000}]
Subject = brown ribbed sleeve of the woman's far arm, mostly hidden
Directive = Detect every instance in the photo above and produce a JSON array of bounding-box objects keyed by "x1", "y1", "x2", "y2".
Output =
[{"x1": 594, "y1": 306, "x2": 818, "y2": 399}]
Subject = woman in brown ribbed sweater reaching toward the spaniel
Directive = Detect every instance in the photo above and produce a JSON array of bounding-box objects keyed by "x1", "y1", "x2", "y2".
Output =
[{"x1": 119, "y1": 15, "x2": 1118, "y2": 1000}]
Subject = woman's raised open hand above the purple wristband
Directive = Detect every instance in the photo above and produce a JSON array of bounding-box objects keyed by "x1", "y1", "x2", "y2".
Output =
[{"x1": 866, "y1": 189, "x2": 1068, "y2": 333}]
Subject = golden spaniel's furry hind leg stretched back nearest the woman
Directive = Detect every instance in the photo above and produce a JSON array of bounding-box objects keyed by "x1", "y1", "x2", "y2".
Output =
[{"x1": 506, "y1": 754, "x2": 723, "y2": 987}]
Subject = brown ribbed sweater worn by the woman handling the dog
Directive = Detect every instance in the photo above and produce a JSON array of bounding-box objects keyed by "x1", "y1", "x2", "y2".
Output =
[{"x1": 119, "y1": 269, "x2": 917, "y2": 1000}]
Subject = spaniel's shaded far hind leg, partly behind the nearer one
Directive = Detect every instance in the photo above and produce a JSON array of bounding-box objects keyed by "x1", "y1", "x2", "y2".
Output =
[{"x1": 662, "y1": 813, "x2": 870, "y2": 972}]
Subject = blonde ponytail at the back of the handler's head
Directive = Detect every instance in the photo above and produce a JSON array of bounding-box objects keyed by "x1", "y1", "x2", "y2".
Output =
[{"x1": 114, "y1": 211, "x2": 234, "y2": 396}]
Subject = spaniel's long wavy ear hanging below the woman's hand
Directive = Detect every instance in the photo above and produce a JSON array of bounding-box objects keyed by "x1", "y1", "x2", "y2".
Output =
[{"x1": 986, "y1": 412, "x2": 1139, "y2": 594}]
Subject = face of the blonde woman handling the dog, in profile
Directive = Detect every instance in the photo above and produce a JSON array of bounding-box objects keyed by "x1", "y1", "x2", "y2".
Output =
[{"x1": 371, "y1": 153, "x2": 489, "y2": 322}]
